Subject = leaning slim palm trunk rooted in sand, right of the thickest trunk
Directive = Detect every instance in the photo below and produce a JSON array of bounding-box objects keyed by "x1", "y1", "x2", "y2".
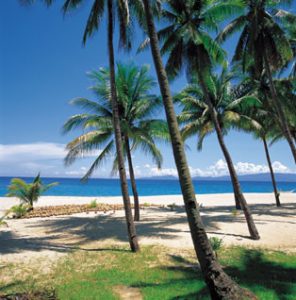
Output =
[{"x1": 198, "y1": 71, "x2": 260, "y2": 240}]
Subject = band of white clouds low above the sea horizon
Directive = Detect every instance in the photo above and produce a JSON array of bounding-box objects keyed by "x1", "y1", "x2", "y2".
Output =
[{"x1": 0, "y1": 142, "x2": 295, "y2": 178}]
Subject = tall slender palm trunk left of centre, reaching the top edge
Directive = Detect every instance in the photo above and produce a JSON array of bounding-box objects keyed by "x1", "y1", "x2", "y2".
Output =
[{"x1": 108, "y1": 0, "x2": 140, "y2": 252}]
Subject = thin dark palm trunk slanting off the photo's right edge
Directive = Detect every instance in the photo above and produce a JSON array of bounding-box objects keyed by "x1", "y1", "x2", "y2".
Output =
[{"x1": 263, "y1": 48, "x2": 296, "y2": 163}]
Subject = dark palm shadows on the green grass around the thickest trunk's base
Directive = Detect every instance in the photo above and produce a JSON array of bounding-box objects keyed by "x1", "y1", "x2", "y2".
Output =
[{"x1": 133, "y1": 249, "x2": 296, "y2": 300}]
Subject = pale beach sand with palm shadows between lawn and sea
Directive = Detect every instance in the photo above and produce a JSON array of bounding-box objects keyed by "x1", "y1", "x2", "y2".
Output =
[{"x1": 0, "y1": 193, "x2": 296, "y2": 263}]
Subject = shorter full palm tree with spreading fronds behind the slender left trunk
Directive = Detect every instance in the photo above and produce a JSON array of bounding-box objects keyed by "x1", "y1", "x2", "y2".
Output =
[{"x1": 63, "y1": 64, "x2": 168, "y2": 221}]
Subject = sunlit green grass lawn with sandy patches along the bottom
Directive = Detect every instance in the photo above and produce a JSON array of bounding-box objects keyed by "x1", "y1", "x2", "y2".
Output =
[{"x1": 0, "y1": 247, "x2": 296, "y2": 300}]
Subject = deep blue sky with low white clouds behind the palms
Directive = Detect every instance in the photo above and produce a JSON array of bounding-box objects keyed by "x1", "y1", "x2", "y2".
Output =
[{"x1": 0, "y1": 0, "x2": 296, "y2": 177}]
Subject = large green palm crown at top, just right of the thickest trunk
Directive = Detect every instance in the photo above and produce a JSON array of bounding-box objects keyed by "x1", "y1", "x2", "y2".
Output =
[{"x1": 140, "y1": 0, "x2": 241, "y2": 78}]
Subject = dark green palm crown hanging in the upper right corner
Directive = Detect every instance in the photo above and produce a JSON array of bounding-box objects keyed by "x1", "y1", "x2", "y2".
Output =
[{"x1": 218, "y1": 0, "x2": 292, "y2": 76}]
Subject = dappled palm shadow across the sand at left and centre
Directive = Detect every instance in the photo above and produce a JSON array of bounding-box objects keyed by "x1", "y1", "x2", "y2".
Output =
[{"x1": 0, "y1": 211, "x2": 190, "y2": 254}]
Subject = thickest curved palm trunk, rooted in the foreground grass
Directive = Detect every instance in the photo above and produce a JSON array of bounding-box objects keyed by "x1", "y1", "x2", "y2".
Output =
[{"x1": 143, "y1": 0, "x2": 252, "y2": 299}]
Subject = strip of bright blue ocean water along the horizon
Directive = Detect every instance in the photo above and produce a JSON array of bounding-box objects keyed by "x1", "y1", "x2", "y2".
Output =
[{"x1": 0, "y1": 177, "x2": 296, "y2": 196}]
